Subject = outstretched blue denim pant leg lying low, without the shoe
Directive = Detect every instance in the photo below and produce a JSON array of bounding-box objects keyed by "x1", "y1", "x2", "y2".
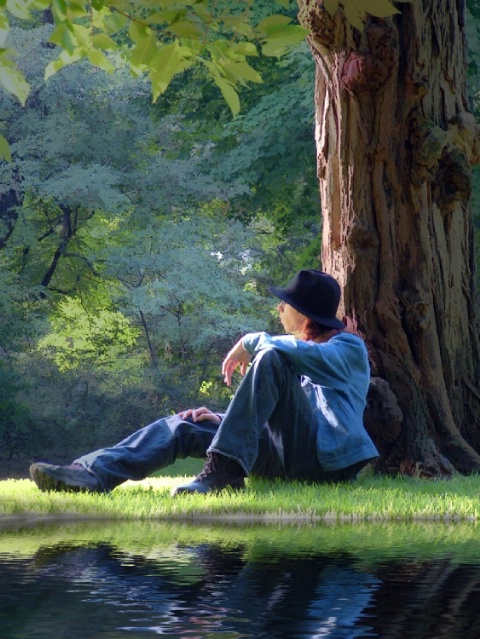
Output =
[{"x1": 74, "y1": 415, "x2": 218, "y2": 490}]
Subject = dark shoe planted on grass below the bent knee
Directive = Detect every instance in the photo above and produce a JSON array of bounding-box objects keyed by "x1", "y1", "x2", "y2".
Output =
[{"x1": 172, "y1": 453, "x2": 245, "y2": 497}]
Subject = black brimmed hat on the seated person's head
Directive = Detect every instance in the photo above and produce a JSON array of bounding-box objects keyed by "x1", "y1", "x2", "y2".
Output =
[{"x1": 269, "y1": 269, "x2": 345, "y2": 329}]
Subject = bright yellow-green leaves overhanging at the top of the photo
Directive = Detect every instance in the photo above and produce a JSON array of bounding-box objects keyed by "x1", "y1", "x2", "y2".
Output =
[{"x1": 0, "y1": 0, "x2": 409, "y2": 160}]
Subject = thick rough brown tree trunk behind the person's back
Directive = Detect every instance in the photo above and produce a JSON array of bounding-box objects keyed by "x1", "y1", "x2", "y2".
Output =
[{"x1": 299, "y1": 0, "x2": 480, "y2": 475}]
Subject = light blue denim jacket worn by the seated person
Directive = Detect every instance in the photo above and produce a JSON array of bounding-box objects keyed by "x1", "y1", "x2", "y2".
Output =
[{"x1": 242, "y1": 332, "x2": 378, "y2": 470}]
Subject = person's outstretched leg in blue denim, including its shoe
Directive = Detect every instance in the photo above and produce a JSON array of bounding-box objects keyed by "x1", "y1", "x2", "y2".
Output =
[{"x1": 30, "y1": 415, "x2": 218, "y2": 492}]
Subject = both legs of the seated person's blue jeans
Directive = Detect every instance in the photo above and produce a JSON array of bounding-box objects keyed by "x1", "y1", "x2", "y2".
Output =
[{"x1": 75, "y1": 349, "x2": 366, "y2": 490}]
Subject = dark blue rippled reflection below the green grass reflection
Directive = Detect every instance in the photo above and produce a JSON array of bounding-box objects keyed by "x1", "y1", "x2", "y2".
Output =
[{"x1": 0, "y1": 530, "x2": 480, "y2": 639}]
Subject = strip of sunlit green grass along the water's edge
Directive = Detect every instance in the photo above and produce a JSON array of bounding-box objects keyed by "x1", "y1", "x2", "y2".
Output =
[{"x1": 0, "y1": 462, "x2": 480, "y2": 524}]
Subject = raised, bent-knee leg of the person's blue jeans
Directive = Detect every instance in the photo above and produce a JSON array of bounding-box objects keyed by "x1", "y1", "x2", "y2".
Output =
[{"x1": 209, "y1": 349, "x2": 329, "y2": 480}]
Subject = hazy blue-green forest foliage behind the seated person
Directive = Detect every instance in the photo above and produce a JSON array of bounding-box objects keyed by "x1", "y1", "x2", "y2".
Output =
[{"x1": 0, "y1": 0, "x2": 480, "y2": 468}]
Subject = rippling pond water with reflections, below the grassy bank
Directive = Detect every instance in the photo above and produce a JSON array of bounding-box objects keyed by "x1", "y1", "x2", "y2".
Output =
[{"x1": 0, "y1": 522, "x2": 480, "y2": 639}]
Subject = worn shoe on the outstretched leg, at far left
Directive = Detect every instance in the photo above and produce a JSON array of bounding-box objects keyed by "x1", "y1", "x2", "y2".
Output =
[{"x1": 30, "y1": 463, "x2": 104, "y2": 493}]
